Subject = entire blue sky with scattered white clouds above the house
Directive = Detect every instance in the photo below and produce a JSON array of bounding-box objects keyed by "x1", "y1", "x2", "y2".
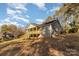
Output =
[{"x1": 0, "y1": 3, "x2": 63, "y2": 27}]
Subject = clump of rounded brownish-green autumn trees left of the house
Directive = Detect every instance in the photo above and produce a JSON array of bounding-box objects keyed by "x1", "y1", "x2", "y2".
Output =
[{"x1": 1, "y1": 24, "x2": 25, "y2": 38}]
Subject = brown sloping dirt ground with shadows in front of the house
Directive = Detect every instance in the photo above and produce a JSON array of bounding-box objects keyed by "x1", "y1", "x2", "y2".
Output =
[{"x1": 0, "y1": 34, "x2": 79, "y2": 56}]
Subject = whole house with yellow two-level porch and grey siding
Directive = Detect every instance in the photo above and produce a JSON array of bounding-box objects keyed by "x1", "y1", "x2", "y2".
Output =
[{"x1": 26, "y1": 18, "x2": 62, "y2": 38}]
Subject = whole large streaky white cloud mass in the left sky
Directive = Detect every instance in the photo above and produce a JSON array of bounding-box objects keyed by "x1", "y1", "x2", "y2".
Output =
[{"x1": 2, "y1": 3, "x2": 30, "y2": 26}]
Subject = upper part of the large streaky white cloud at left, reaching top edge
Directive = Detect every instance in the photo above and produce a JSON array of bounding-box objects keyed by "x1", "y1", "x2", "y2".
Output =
[{"x1": 7, "y1": 3, "x2": 27, "y2": 15}]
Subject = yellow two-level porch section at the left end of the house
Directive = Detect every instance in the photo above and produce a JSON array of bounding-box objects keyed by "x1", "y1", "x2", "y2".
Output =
[{"x1": 26, "y1": 23, "x2": 42, "y2": 38}]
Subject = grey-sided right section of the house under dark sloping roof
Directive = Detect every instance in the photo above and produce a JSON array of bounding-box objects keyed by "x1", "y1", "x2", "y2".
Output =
[{"x1": 42, "y1": 16, "x2": 63, "y2": 37}]
